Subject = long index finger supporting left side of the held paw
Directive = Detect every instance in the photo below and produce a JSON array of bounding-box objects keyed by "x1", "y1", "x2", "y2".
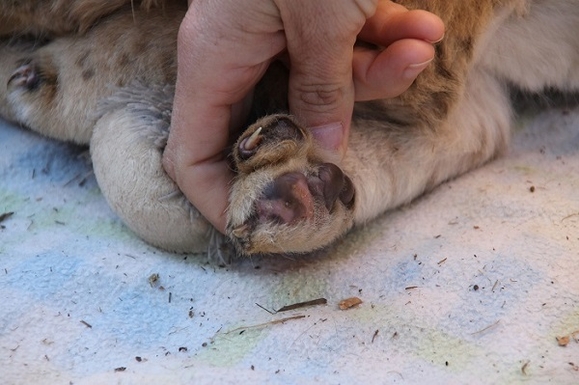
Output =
[{"x1": 163, "y1": 0, "x2": 284, "y2": 232}]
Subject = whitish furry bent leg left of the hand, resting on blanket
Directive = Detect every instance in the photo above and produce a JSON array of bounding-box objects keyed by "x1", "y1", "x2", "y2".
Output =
[{"x1": 90, "y1": 84, "x2": 219, "y2": 255}]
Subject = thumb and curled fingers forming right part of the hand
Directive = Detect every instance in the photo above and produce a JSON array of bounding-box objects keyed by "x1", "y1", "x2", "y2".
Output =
[{"x1": 278, "y1": 0, "x2": 444, "y2": 153}]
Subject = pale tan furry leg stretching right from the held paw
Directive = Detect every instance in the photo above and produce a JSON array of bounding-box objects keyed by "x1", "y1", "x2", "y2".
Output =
[{"x1": 343, "y1": 68, "x2": 512, "y2": 224}]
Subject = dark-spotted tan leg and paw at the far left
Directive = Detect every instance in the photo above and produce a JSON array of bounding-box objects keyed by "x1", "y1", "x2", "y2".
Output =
[{"x1": 0, "y1": 7, "x2": 183, "y2": 143}]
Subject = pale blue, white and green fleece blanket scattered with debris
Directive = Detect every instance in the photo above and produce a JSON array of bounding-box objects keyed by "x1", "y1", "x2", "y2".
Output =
[{"x1": 0, "y1": 104, "x2": 579, "y2": 384}]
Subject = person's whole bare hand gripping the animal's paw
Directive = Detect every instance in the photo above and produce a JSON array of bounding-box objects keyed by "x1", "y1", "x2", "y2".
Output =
[{"x1": 163, "y1": 0, "x2": 444, "y2": 232}]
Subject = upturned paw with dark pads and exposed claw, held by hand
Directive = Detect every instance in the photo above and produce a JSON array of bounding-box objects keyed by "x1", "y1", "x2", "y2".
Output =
[{"x1": 227, "y1": 115, "x2": 355, "y2": 254}]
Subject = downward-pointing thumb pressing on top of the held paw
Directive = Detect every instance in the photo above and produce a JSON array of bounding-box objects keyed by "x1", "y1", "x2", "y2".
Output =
[{"x1": 280, "y1": 0, "x2": 376, "y2": 154}]
